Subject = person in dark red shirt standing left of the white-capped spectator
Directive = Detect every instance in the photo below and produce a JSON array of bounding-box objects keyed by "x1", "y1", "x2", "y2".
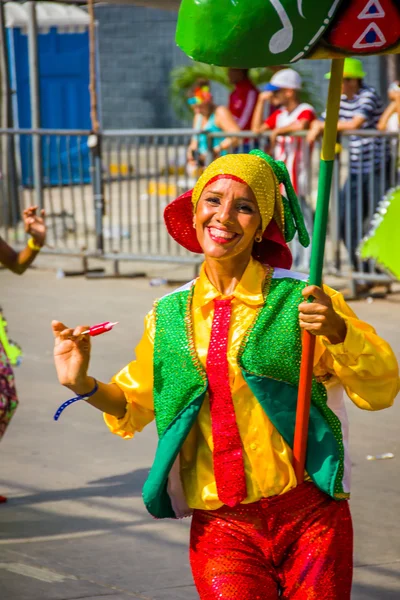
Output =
[{"x1": 228, "y1": 69, "x2": 259, "y2": 131}]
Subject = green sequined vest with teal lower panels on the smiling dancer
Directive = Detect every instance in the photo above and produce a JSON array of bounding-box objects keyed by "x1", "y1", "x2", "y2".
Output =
[{"x1": 143, "y1": 277, "x2": 347, "y2": 518}]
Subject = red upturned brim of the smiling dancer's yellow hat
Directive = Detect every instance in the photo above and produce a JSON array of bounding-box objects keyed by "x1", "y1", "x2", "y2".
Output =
[{"x1": 164, "y1": 190, "x2": 293, "y2": 269}]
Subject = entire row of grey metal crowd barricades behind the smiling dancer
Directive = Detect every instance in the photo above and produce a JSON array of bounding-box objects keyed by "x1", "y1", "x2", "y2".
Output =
[{"x1": 0, "y1": 129, "x2": 399, "y2": 288}]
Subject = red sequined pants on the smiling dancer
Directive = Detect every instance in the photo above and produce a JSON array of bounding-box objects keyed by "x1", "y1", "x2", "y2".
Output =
[{"x1": 190, "y1": 483, "x2": 353, "y2": 600}]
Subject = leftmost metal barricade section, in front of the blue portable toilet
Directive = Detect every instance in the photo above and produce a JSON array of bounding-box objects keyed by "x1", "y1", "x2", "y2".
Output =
[{"x1": 0, "y1": 129, "x2": 95, "y2": 255}]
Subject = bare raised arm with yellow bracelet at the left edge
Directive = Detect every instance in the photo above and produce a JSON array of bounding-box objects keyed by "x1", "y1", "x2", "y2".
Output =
[{"x1": 0, "y1": 206, "x2": 46, "y2": 275}]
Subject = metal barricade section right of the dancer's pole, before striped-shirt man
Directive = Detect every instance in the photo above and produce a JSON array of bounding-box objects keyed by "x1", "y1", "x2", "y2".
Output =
[{"x1": 329, "y1": 130, "x2": 400, "y2": 292}]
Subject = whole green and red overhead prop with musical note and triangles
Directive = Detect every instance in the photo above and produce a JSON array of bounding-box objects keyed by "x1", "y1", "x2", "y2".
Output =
[{"x1": 176, "y1": 0, "x2": 400, "y2": 68}]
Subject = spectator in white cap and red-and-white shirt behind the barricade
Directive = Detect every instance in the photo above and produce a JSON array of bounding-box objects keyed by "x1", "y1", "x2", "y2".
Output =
[{"x1": 252, "y1": 69, "x2": 316, "y2": 270}]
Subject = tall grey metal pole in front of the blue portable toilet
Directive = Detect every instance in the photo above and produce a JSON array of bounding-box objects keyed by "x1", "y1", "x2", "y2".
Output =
[{"x1": 27, "y1": 2, "x2": 43, "y2": 208}]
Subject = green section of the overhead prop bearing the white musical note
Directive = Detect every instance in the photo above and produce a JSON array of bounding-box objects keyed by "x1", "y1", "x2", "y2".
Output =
[{"x1": 176, "y1": 0, "x2": 340, "y2": 67}]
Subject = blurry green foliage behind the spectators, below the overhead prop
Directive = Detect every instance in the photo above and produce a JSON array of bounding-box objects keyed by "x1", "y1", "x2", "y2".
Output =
[{"x1": 169, "y1": 61, "x2": 322, "y2": 121}]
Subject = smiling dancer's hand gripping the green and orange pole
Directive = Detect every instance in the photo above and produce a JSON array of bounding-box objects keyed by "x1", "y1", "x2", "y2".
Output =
[{"x1": 299, "y1": 285, "x2": 347, "y2": 344}]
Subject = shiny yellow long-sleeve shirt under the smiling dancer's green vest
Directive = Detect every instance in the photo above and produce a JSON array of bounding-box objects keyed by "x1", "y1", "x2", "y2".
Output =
[{"x1": 105, "y1": 260, "x2": 399, "y2": 510}]
